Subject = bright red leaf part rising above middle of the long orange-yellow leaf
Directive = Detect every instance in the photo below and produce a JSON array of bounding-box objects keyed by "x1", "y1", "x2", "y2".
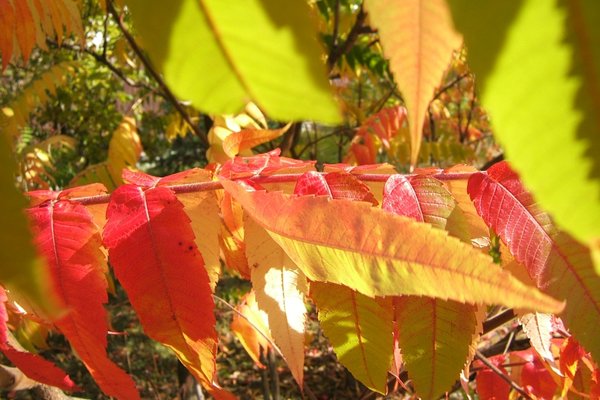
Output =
[{"x1": 294, "y1": 171, "x2": 378, "y2": 205}]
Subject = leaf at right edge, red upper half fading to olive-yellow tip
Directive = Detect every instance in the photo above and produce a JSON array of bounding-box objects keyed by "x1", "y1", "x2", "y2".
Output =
[{"x1": 468, "y1": 162, "x2": 600, "y2": 358}]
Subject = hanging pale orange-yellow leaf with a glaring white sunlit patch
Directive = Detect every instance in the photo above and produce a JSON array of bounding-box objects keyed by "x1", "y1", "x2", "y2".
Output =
[{"x1": 244, "y1": 218, "x2": 307, "y2": 387}]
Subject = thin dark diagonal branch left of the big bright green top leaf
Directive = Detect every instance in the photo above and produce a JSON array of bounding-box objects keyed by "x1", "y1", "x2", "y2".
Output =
[{"x1": 106, "y1": 0, "x2": 209, "y2": 147}]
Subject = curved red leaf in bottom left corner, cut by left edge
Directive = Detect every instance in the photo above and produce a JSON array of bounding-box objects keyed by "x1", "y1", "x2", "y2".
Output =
[{"x1": 0, "y1": 286, "x2": 80, "y2": 391}]
